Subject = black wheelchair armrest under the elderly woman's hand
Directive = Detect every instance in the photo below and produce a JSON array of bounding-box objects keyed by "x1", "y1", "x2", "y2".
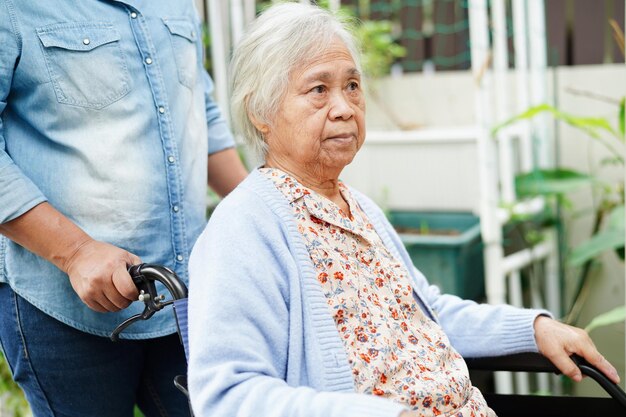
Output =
[{"x1": 465, "y1": 353, "x2": 626, "y2": 408}]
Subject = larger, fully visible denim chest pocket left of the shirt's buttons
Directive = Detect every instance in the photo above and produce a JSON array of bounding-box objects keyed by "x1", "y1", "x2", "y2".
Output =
[{"x1": 37, "y1": 23, "x2": 130, "y2": 109}]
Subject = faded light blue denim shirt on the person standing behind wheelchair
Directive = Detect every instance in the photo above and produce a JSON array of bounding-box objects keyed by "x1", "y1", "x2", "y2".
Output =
[{"x1": 0, "y1": 0, "x2": 234, "y2": 339}]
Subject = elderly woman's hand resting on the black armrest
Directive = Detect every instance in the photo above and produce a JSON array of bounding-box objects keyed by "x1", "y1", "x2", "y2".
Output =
[{"x1": 534, "y1": 316, "x2": 620, "y2": 384}]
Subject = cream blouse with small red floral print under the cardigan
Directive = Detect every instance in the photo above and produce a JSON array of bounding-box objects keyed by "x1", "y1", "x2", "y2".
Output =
[{"x1": 260, "y1": 168, "x2": 495, "y2": 417}]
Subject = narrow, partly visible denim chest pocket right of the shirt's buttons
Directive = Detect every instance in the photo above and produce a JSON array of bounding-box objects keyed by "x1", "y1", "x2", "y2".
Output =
[{"x1": 163, "y1": 18, "x2": 198, "y2": 88}]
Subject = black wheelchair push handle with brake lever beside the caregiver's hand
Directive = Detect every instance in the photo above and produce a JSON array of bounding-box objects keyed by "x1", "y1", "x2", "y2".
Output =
[{"x1": 111, "y1": 264, "x2": 187, "y2": 342}]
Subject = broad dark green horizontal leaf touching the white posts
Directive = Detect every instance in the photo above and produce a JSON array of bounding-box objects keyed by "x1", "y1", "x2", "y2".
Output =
[{"x1": 515, "y1": 169, "x2": 595, "y2": 197}]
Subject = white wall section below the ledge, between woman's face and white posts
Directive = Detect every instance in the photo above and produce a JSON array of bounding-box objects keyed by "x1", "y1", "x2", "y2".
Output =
[{"x1": 342, "y1": 128, "x2": 479, "y2": 212}]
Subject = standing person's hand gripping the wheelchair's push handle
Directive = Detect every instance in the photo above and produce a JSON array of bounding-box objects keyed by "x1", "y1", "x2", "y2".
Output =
[{"x1": 63, "y1": 239, "x2": 141, "y2": 313}]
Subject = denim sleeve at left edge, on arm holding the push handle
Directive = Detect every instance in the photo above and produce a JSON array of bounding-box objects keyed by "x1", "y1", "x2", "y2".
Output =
[{"x1": 0, "y1": 1, "x2": 46, "y2": 224}]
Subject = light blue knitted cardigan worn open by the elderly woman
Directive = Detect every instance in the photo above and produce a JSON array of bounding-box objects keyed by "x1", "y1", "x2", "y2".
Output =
[{"x1": 188, "y1": 171, "x2": 545, "y2": 417}]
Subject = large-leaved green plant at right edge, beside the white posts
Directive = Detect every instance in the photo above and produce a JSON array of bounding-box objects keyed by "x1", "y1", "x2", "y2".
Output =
[{"x1": 492, "y1": 98, "x2": 626, "y2": 331}]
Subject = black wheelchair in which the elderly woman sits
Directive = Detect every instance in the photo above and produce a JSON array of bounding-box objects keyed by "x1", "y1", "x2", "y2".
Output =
[{"x1": 111, "y1": 264, "x2": 626, "y2": 417}]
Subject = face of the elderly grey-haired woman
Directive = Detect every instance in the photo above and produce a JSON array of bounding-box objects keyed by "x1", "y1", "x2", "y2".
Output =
[{"x1": 265, "y1": 40, "x2": 365, "y2": 180}]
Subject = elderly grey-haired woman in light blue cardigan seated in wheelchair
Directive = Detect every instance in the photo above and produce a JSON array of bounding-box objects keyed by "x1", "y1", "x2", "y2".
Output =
[{"x1": 189, "y1": 3, "x2": 618, "y2": 417}]
